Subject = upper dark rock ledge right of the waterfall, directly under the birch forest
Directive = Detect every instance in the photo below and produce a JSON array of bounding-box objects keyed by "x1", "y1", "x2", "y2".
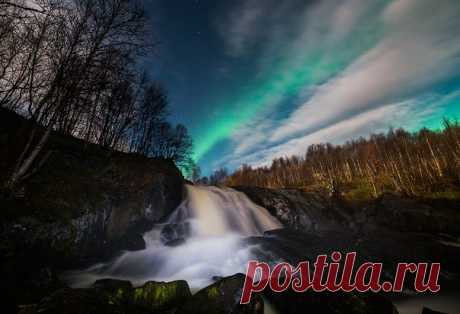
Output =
[{"x1": 235, "y1": 186, "x2": 460, "y2": 238}]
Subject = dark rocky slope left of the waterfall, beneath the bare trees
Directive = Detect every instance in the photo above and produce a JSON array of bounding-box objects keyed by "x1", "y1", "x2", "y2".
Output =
[{"x1": 0, "y1": 110, "x2": 184, "y2": 312}]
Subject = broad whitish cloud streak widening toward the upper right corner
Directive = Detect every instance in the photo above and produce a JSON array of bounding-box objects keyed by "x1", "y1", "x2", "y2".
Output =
[{"x1": 271, "y1": 0, "x2": 460, "y2": 141}]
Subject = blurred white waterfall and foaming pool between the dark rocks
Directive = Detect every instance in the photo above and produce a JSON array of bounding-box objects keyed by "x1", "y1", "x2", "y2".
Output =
[{"x1": 67, "y1": 185, "x2": 281, "y2": 289}]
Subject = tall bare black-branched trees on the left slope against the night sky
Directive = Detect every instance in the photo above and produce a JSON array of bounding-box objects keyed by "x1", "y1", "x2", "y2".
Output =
[{"x1": 0, "y1": 0, "x2": 192, "y2": 188}]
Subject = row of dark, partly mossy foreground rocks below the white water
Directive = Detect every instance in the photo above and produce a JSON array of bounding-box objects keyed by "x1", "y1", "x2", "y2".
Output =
[{"x1": 20, "y1": 274, "x2": 264, "y2": 314}]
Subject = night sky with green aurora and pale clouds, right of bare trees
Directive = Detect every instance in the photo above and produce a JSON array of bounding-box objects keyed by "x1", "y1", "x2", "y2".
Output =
[{"x1": 143, "y1": 0, "x2": 460, "y2": 175}]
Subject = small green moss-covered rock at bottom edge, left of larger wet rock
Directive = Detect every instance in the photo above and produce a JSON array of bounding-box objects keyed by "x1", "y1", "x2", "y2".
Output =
[{"x1": 133, "y1": 280, "x2": 192, "y2": 312}]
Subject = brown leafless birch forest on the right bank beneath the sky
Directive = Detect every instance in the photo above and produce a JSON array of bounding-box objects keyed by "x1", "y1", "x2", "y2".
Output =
[{"x1": 226, "y1": 120, "x2": 460, "y2": 197}]
